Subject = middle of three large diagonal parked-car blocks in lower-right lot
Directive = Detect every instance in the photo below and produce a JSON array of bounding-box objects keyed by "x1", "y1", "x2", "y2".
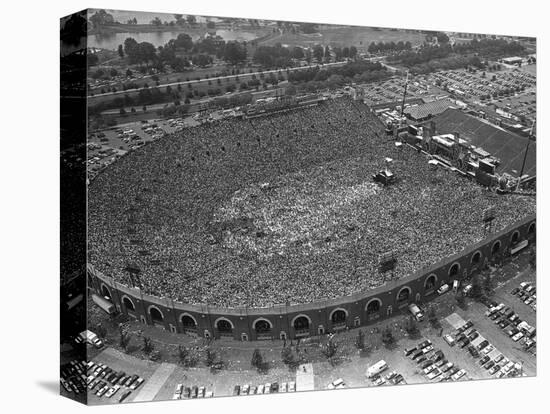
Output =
[{"x1": 444, "y1": 321, "x2": 521, "y2": 378}]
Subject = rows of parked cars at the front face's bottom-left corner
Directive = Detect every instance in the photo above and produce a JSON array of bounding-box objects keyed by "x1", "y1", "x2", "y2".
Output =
[{"x1": 85, "y1": 361, "x2": 145, "y2": 402}]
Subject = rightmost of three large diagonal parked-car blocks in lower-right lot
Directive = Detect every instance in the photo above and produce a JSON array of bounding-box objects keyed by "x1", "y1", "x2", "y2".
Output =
[{"x1": 485, "y1": 303, "x2": 537, "y2": 350}]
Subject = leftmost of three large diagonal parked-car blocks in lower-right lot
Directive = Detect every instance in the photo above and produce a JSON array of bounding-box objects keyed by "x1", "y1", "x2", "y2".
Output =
[{"x1": 405, "y1": 339, "x2": 466, "y2": 382}]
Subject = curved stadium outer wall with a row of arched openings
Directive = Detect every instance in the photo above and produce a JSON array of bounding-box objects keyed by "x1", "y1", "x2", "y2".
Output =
[{"x1": 88, "y1": 215, "x2": 536, "y2": 341}]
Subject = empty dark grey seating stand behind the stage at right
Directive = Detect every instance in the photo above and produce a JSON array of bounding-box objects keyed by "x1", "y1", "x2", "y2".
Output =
[{"x1": 434, "y1": 108, "x2": 537, "y2": 176}]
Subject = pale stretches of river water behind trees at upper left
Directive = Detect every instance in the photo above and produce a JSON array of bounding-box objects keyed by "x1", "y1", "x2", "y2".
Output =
[{"x1": 88, "y1": 30, "x2": 258, "y2": 50}]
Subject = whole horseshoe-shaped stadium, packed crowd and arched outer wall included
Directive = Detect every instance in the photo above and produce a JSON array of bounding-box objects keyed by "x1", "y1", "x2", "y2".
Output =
[{"x1": 88, "y1": 97, "x2": 536, "y2": 340}]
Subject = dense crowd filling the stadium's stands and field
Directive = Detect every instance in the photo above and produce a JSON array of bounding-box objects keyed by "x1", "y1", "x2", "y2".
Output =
[{"x1": 89, "y1": 98, "x2": 535, "y2": 307}]
